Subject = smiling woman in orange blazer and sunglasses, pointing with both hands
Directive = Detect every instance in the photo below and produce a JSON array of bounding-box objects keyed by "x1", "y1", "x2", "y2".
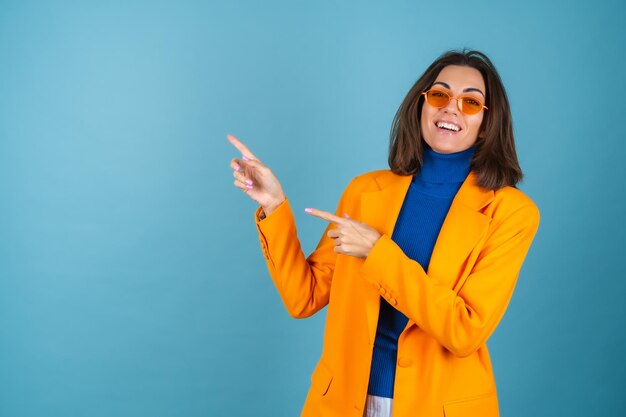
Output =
[{"x1": 229, "y1": 51, "x2": 539, "y2": 417}]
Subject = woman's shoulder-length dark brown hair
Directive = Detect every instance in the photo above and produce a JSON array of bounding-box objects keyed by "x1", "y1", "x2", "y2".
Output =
[{"x1": 389, "y1": 50, "x2": 522, "y2": 190}]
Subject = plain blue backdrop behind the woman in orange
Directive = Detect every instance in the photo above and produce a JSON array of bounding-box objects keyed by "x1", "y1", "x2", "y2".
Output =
[{"x1": 0, "y1": 0, "x2": 626, "y2": 417}]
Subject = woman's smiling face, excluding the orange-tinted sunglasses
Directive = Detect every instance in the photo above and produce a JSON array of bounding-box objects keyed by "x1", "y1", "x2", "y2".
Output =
[{"x1": 420, "y1": 65, "x2": 486, "y2": 153}]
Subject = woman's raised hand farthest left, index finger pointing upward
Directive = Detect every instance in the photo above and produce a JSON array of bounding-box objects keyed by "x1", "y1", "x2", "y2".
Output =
[{"x1": 226, "y1": 135, "x2": 286, "y2": 216}]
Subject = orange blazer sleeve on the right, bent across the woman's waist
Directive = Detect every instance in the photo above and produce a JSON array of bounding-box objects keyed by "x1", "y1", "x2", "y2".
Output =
[{"x1": 361, "y1": 203, "x2": 539, "y2": 357}]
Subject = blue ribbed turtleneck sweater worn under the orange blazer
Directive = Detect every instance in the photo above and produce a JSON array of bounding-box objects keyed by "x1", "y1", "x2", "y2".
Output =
[{"x1": 368, "y1": 147, "x2": 474, "y2": 398}]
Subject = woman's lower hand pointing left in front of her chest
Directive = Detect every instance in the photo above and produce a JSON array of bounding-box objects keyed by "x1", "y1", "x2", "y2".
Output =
[{"x1": 304, "y1": 208, "x2": 381, "y2": 258}]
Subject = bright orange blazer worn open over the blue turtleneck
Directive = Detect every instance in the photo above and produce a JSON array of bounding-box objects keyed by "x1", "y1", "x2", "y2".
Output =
[{"x1": 256, "y1": 171, "x2": 539, "y2": 417}]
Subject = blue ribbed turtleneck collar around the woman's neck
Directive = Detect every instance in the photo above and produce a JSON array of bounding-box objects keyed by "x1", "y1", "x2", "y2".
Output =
[{"x1": 414, "y1": 146, "x2": 476, "y2": 184}]
